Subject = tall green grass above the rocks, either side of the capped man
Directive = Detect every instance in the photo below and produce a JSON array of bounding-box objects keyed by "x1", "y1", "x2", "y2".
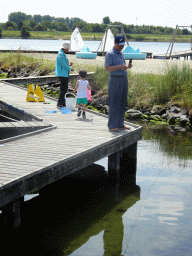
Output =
[{"x1": 89, "y1": 64, "x2": 192, "y2": 109}]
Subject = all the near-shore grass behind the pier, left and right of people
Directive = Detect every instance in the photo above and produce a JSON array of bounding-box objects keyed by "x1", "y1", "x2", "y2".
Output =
[{"x1": 0, "y1": 53, "x2": 192, "y2": 109}]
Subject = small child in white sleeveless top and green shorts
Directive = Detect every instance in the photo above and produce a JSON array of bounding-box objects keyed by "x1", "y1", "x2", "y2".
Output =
[{"x1": 73, "y1": 69, "x2": 90, "y2": 118}]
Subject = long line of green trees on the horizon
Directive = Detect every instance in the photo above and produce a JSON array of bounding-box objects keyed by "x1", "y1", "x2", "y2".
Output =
[{"x1": 0, "y1": 12, "x2": 191, "y2": 37}]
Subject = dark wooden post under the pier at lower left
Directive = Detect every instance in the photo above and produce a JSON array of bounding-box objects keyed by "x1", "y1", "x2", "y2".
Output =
[{"x1": 2, "y1": 197, "x2": 24, "y2": 230}]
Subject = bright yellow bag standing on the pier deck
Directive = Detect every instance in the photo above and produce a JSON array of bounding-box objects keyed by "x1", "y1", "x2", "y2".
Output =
[{"x1": 26, "y1": 84, "x2": 45, "y2": 102}]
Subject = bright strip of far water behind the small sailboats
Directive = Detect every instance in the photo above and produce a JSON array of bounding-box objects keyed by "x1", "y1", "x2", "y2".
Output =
[{"x1": 0, "y1": 39, "x2": 191, "y2": 54}]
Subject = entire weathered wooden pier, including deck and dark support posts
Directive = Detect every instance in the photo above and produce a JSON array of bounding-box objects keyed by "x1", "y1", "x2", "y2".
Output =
[{"x1": 0, "y1": 81, "x2": 142, "y2": 228}]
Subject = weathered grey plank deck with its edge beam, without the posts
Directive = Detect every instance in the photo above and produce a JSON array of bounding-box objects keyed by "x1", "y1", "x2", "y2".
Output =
[{"x1": 0, "y1": 82, "x2": 142, "y2": 207}]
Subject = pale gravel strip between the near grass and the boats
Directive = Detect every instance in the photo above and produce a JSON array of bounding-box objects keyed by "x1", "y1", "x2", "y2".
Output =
[{"x1": 27, "y1": 53, "x2": 192, "y2": 74}]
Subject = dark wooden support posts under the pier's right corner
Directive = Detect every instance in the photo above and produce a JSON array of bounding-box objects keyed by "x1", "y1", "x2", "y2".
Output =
[{"x1": 108, "y1": 143, "x2": 137, "y2": 189}]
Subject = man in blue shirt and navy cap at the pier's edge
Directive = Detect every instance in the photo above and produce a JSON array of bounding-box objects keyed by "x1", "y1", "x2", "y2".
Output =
[{"x1": 105, "y1": 35, "x2": 132, "y2": 131}]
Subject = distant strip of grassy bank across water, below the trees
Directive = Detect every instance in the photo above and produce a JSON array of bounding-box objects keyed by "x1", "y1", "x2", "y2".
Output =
[{"x1": 2, "y1": 30, "x2": 191, "y2": 43}]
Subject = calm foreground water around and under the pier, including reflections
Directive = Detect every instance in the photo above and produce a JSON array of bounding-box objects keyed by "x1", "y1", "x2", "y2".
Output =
[{"x1": 2, "y1": 127, "x2": 192, "y2": 256}]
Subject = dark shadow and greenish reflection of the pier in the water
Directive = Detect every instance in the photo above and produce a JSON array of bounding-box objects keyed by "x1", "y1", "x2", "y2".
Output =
[{"x1": 2, "y1": 165, "x2": 140, "y2": 256}]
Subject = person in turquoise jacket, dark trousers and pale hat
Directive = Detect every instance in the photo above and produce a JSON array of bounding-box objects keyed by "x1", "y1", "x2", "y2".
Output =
[{"x1": 55, "y1": 43, "x2": 73, "y2": 107}]
